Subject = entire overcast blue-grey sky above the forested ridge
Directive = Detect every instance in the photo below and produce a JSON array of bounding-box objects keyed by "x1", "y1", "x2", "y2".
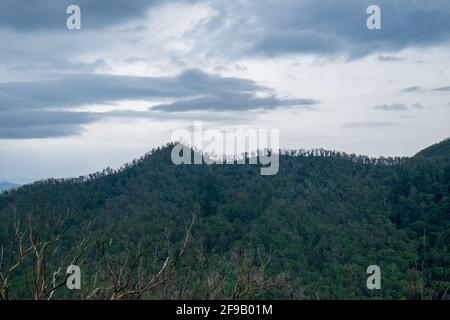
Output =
[{"x1": 0, "y1": 0, "x2": 450, "y2": 183}]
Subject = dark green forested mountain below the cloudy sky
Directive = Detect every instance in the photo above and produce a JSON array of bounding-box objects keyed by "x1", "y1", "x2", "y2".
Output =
[{"x1": 0, "y1": 140, "x2": 450, "y2": 299}]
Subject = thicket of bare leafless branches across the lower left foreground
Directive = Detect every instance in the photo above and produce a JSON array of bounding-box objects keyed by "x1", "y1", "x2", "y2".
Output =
[{"x1": 0, "y1": 208, "x2": 283, "y2": 300}]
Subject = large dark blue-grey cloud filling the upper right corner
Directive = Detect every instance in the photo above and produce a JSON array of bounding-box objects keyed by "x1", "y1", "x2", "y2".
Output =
[{"x1": 200, "y1": 0, "x2": 450, "y2": 61}]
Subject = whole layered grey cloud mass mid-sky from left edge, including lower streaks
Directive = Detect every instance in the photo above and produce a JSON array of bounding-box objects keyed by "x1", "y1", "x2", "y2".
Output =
[{"x1": 0, "y1": 69, "x2": 318, "y2": 139}]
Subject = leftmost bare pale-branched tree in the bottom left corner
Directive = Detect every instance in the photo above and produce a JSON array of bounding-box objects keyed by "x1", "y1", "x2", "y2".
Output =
[{"x1": 0, "y1": 209, "x2": 88, "y2": 300}]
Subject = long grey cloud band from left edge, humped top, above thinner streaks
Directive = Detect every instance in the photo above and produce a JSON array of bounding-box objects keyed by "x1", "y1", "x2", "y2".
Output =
[{"x1": 0, "y1": 70, "x2": 270, "y2": 111}]
